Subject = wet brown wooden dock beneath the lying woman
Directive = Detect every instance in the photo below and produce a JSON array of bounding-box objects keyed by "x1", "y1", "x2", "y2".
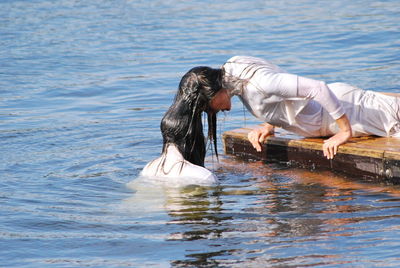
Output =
[{"x1": 222, "y1": 128, "x2": 400, "y2": 184}]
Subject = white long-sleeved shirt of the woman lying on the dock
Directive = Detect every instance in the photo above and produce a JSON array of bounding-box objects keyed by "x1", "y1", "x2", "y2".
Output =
[{"x1": 223, "y1": 56, "x2": 344, "y2": 136}]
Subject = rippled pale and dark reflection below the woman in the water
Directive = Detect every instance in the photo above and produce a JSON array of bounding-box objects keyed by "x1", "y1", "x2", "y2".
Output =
[{"x1": 123, "y1": 177, "x2": 232, "y2": 266}]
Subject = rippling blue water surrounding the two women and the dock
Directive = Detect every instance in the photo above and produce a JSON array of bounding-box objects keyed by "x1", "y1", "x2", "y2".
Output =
[{"x1": 0, "y1": 0, "x2": 400, "y2": 267}]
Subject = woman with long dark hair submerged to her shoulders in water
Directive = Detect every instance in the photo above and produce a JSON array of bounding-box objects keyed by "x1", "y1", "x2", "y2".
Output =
[{"x1": 141, "y1": 67, "x2": 230, "y2": 184}]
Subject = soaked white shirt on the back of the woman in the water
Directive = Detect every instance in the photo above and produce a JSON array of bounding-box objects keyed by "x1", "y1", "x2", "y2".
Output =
[{"x1": 141, "y1": 144, "x2": 218, "y2": 185}]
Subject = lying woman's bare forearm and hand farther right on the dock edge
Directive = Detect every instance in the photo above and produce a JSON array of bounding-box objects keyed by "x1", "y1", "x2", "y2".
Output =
[{"x1": 322, "y1": 115, "x2": 352, "y2": 159}]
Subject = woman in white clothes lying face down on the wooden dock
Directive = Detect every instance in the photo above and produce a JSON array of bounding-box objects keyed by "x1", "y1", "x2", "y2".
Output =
[{"x1": 197, "y1": 56, "x2": 400, "y2": 159}]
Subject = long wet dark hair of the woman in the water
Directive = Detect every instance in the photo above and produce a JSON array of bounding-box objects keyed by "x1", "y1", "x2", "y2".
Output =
[{"x1": 161, "y1": 67, "x2": 222, "y2": 166}]
